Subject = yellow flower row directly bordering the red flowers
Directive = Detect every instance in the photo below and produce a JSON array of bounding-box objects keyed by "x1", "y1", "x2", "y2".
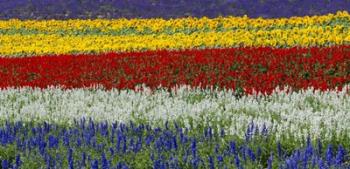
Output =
[{"x1": 0, "y1": 28, "x2": 350, "y2": 56}]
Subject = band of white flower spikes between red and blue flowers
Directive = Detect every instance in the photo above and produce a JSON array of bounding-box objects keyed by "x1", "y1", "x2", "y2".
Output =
[{"x1": 0, "y1": 86, "x2": 350, "y2": 138}]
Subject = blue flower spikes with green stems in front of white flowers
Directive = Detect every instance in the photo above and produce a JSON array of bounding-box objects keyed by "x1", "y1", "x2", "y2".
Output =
[{"x1": 0, "y1": 119, "x2": 350, "y2": 169}]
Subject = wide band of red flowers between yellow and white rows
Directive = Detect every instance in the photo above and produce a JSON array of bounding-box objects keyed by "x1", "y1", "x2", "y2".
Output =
[{"x1": 0, "y1": 46, "x2": 350, "y2": 93}]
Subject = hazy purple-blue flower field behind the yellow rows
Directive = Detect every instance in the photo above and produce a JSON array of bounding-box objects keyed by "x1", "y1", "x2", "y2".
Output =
[{"x1": 0, "y1": 0, "x2": 350, "y2": 19}]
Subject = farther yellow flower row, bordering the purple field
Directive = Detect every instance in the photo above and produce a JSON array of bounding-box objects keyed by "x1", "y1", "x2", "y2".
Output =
[{"x1": 0, "y1": 11, "x2": 350, "y2": 32}]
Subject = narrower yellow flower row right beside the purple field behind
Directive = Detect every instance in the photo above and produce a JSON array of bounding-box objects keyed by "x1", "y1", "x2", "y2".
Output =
[{"x1": 0, "y1": 11, "x2": 350, "y2": 35}]
